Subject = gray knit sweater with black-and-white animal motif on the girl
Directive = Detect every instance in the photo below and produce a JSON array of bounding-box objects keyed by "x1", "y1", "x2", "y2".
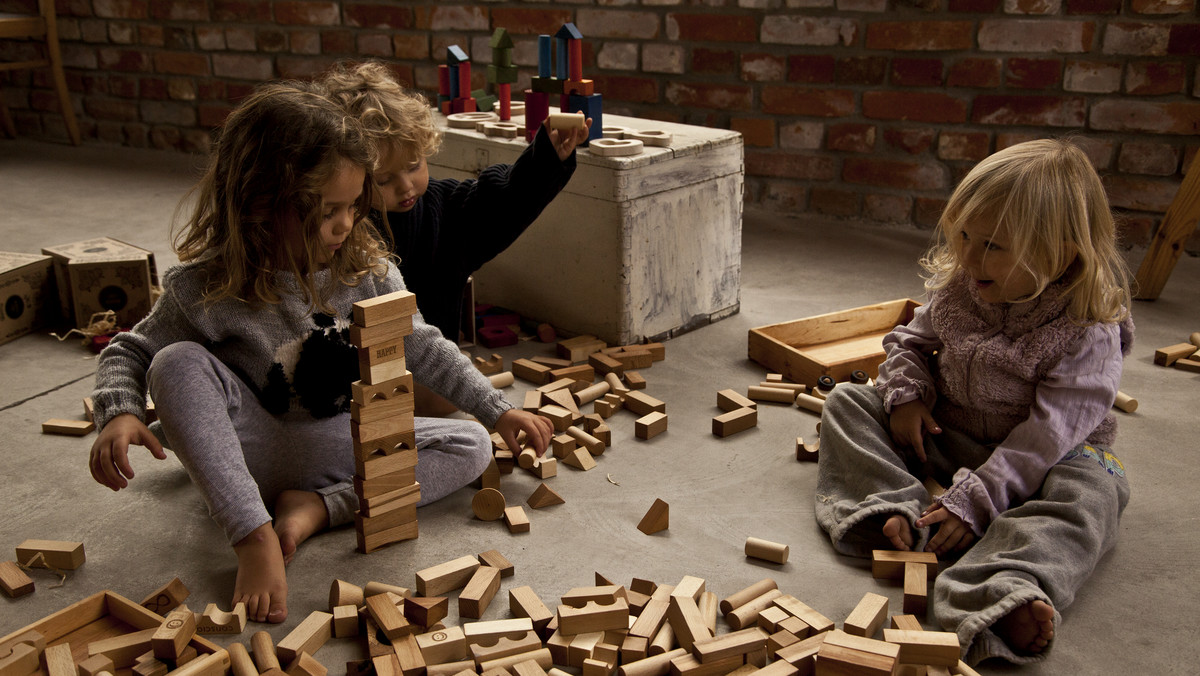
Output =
[{"x1": 92, "y1": 261, "x2": 512, "y2": 431}]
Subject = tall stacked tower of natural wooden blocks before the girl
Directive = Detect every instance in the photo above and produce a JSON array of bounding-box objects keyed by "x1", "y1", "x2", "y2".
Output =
[{"x1": 350, "y1": 291, "x2": 421, "y2": 554}]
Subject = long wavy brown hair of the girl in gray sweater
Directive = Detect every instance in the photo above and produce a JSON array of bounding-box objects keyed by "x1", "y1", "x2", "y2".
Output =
[{"x1": 173, "y1": 82, "x2": 389, "y2": 312}]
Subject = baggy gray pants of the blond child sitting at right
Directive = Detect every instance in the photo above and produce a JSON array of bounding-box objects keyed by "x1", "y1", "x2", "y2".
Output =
[{"x1": 816, "y1": 384, "x2": 1129, "y2": 664}]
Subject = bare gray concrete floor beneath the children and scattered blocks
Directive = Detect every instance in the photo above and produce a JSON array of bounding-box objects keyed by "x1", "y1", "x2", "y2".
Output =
[{"x1": 0, "y1": 140, "x2": 1200, "y2": 674}]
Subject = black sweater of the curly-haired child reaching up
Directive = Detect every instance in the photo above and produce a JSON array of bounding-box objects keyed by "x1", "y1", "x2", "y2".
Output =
[{"x1": 388, "y1": 127, "x2": 575, "y2": 342}]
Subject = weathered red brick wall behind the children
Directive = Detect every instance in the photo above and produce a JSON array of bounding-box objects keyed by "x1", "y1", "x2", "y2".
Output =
[{"x1": 0, "y1": 0, "x2": 1200, "y2": 252}]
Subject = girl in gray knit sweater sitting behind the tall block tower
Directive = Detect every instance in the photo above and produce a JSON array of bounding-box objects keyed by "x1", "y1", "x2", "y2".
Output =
[{"x1": 90, "y1": 83, "x2": 552, "y2": 622}]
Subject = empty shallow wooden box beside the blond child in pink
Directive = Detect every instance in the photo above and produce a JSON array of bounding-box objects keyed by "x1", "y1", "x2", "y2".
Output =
[{"x1": 749, "y1": 298, "x2": 920, "y2": 385}]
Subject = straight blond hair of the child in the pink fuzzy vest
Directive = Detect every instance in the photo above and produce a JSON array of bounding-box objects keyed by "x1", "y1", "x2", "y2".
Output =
[{"x1": 920, "y1": 139, "x2": 1130, "y2": 324}]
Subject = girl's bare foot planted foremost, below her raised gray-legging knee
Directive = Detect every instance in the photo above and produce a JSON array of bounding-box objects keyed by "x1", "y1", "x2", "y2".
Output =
[{"x1": 233, "y1": 524, "x2": 288, "y2": 623}]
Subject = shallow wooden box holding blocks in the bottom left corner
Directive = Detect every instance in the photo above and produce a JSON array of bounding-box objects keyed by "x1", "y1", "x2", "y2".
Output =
[{"x1": 0, "y1": 591, "x2": 220, "y2": 676}]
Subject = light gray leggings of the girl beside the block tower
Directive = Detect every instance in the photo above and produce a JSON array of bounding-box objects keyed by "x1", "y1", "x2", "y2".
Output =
[{"x1": 148, "y1": 342, "x2": 492, "y2": 544}]
